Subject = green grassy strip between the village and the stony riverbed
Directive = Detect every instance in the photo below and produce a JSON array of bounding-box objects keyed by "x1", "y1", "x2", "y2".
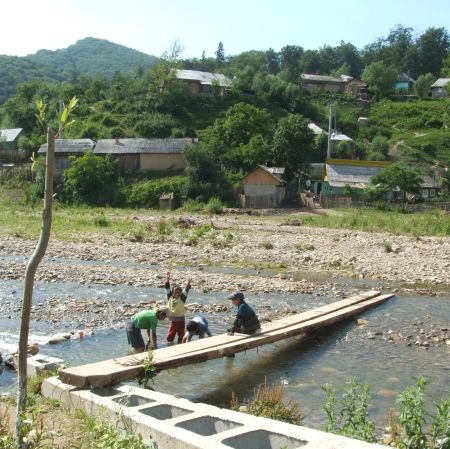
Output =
[{"x1": 0, "y1": 186, "x2": 450, "y2": 241}]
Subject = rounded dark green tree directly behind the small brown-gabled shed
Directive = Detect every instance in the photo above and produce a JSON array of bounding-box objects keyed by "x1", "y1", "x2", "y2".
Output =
[{"x1": 272, "y1": 114, "x2": 315, "y2": 180}]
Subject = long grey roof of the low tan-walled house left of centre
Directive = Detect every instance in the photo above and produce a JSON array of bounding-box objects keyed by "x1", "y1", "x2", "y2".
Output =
[{"x1": 94, "y1": 137, "x2": 196, "y2": 154}]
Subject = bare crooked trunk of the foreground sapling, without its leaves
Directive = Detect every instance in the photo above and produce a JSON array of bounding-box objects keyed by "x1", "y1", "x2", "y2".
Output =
[{"x1": 16, "y1": 128, "x2": 55, "y2": 449}]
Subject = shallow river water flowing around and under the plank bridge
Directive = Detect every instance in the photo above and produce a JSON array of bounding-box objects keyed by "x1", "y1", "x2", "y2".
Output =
[{"x1": 0, "y1": 274, "x2": 450, "y2": 428}]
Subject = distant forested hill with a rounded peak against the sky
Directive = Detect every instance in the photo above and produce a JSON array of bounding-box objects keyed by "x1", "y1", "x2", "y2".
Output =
[{"x1": 0, "y1": 37, "x2": 157, "y2": 104}]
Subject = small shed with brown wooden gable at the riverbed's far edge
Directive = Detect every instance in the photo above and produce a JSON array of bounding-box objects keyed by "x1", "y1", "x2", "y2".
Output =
[{"x1": 241, "y1": 165, "x2": 286, "y2": 209}]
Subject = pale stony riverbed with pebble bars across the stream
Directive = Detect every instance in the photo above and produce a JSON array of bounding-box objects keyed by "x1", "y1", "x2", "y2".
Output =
[{"x1": 0, "y1": 215, "x2": 450, "y2": 338}]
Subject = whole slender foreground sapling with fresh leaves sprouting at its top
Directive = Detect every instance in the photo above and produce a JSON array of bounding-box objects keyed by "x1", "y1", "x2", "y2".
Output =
[{"x1": 16, "y1": 97, "x2": 78, "y2": 449}]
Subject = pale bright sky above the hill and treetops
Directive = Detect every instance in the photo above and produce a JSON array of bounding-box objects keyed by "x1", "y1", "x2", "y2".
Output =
[{"x1": 0, "y1": 0, "x2": 450, "y2": 58}]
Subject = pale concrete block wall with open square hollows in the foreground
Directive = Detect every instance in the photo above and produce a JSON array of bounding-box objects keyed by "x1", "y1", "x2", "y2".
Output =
[{"x1": 42, "y1": 377, "x2": 385, "y2": 449}]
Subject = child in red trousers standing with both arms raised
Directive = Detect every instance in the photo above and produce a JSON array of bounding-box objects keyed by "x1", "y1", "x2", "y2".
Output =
[{"x1": 166, "y1": 271, "x2": 191, "y2": 343}]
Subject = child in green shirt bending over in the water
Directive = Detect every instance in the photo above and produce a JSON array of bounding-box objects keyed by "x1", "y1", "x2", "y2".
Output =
[{"x1": 127, "y1": 308, "x2": 169, "y2": 352}]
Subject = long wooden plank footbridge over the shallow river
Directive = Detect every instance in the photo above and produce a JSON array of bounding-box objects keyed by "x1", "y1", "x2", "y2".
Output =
[{"x1": 59, "y1": 290, "x2": 394, "y2": 388}]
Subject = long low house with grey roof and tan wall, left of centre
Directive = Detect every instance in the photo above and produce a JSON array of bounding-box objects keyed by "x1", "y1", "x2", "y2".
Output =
[{"x1": 94, "y1": 137, "x2": 197, "y2": 172}]
